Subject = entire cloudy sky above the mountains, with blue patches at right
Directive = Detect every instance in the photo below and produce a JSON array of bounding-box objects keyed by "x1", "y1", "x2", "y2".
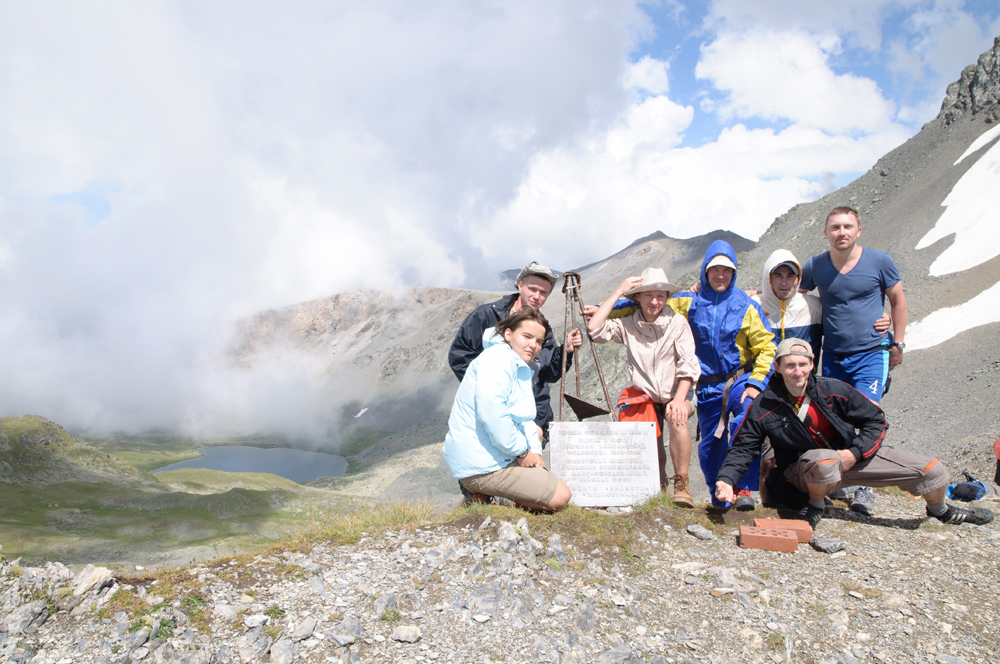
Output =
[{"x1": 0, "y1": 0, "x2": 1000, "y2": 430}]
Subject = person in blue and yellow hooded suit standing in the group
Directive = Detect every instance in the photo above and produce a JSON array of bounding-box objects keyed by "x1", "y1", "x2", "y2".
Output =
[{"x1": 667, "y1": 240, "x2": 774, "y2": 511}]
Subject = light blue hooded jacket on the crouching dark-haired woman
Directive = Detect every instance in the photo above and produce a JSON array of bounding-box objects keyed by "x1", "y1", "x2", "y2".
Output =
[{"x1": 444, "y1": 328, "x2": 542, "y2": 479}]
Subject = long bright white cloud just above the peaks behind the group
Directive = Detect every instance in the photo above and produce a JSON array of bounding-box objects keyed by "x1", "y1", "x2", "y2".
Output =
[{"x1": 476, "y1": 96, "x2": 906, "y2": 268}]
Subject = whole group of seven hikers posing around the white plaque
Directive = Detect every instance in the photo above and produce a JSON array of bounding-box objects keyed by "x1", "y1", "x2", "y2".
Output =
[{"x1": 444, "y1": 207, "x2": 1000, "y2": 528}]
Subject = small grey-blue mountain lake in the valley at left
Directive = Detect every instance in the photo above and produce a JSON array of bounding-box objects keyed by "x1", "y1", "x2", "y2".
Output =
[{"x1": 153, "y1": 445, "x2": 347, "y2": 483}]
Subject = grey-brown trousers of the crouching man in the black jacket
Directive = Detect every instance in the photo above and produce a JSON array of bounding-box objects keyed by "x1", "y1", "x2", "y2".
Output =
[{"x1": 785, "y1": 445, "x2": 948, "y2": 496}]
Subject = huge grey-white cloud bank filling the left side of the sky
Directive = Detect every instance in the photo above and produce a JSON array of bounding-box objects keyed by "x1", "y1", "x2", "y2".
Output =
[{"x1": 0, "y1": 0, "x2": 648, "y2": 430}]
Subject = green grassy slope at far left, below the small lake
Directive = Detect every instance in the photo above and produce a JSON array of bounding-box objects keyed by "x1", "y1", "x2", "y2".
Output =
[{"x1": 0, "y1": 415, "x2": 354, "y2": 566}]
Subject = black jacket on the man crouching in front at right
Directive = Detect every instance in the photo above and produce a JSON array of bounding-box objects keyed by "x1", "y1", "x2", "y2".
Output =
[{"x1": 719, "y1": 373, "x2": 889, "y2": 486}]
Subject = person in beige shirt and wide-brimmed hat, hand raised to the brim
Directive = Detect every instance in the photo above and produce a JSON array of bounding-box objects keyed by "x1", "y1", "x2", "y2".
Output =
[{"x1": 587, "y1": 267, "x2": 701, "y2": 507}]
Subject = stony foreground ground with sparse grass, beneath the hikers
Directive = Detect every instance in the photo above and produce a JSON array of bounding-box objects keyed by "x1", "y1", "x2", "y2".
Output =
[{"x1": 0, "y1": 491, "x2": 1000, "y2": 664}]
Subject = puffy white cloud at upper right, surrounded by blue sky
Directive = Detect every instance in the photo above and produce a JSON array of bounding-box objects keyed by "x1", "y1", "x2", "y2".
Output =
[{"x1": 695, "y1": 30, "x2": 895, "y2": 133}]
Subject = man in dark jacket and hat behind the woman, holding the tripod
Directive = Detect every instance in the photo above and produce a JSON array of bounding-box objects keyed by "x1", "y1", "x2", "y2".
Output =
[{"x1": 448, "y1": 262, "x2": 583, "y2": 440}]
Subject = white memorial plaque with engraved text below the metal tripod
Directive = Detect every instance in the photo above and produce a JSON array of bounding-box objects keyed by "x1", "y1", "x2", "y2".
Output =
[{"x1": 549, "y1": 422, "x2": 660, "y2": 507}]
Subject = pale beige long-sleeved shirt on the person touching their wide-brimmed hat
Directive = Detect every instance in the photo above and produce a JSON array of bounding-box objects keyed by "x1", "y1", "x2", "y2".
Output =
[{"x1": 592, "y1": 307, "x2": 701, "y2": 403}]
